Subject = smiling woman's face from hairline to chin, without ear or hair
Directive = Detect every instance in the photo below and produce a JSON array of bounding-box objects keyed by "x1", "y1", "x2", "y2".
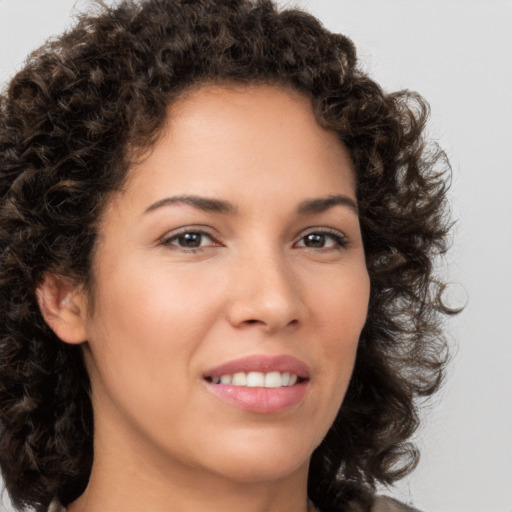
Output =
[{"x1": 78, "y1": 86, "x2": 369, "y2": 488}]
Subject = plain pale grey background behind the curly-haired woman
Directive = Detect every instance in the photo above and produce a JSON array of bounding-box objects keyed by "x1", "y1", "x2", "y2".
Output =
[{"x1": 0, "y1": 0, "x2": 512, "y2": 512}]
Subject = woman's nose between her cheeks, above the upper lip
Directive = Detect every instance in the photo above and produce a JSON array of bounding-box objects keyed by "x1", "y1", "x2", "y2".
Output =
[{"x1": 228, "y1": 250, "x2": 306, "y2": 334}]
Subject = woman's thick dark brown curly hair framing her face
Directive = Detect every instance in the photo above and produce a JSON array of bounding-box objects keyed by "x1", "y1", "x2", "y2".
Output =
[{"x1": 0, "y1": 0, "x2": 450, "y2": 511}]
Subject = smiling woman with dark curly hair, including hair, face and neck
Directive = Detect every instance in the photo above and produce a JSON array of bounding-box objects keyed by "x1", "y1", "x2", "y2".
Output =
[{"x1": 0, "y1": 0, "x2": 448, "y2": 512}]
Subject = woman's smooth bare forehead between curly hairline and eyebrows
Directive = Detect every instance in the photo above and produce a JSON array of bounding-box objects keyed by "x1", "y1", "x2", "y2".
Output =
[{"x1": 121, "y1": 84, "x2": 355, "y2": 210}]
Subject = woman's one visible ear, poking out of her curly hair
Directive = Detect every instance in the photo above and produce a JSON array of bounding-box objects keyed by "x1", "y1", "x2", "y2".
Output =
[{"x1": 36, "y1": 272, "x2": 87, "y2": 344}]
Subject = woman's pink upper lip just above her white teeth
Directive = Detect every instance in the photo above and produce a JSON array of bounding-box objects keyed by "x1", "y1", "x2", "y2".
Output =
[{"x1": 204, "y1": 355, "x2": 309, "y2": 379}]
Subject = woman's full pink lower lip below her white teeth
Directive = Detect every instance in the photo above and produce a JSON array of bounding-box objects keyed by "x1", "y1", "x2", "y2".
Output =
[{"x1": 206, "y1": 381, "x2": 308, "y2": 414}]
